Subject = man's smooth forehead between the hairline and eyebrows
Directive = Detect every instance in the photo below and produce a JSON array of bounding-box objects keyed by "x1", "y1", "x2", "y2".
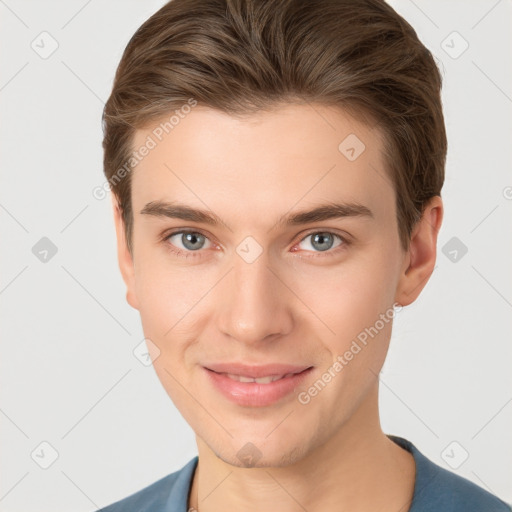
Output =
[{"x1": 132, "y1": 104, "x2": 394, "y2": 229}]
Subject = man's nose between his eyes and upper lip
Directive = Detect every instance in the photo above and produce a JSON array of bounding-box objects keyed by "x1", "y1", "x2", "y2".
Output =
[{"x1": 216, "y1": 251, "x2": 293, "y2": 344}]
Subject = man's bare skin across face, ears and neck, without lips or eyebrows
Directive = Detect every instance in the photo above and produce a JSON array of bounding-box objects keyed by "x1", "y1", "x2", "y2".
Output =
[{"x1": 113, "y1": 104, "x2": 443, "y2": 512}]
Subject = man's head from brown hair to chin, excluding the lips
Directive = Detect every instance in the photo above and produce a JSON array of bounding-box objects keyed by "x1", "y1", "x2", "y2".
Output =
[{"x1": 104, "y1": 0, "x2": 447, "y2": 465}]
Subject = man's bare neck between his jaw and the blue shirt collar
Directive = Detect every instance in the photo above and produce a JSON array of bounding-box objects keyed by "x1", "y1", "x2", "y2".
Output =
[{"x1": 189, "y1": 383, "x2": 415, "y2": 512}]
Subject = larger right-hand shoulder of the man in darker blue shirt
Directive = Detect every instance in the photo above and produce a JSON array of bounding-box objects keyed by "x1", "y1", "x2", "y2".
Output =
[{"x1": 389, "y1": 436, "x2": 512, "y2": 512}]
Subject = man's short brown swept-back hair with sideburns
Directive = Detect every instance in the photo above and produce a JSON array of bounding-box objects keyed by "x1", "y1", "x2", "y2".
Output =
[{"x1": 103, "y1": 0, "x2": 447, "y2": 255}]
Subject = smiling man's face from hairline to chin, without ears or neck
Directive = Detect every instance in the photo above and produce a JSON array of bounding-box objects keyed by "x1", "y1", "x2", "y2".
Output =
[{"x1": 119, "y1": 105, "x2": 406, "y2": 466}]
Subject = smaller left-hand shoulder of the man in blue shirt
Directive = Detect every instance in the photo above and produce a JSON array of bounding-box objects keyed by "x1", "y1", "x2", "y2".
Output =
[{"x1": 96, "y1": 456, "x2": 198, "y2": 512}]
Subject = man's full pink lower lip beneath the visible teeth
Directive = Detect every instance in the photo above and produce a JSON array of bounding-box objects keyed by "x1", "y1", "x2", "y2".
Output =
[{"x1": 204, "y1": 368, "x2": 313, "y2": 407}]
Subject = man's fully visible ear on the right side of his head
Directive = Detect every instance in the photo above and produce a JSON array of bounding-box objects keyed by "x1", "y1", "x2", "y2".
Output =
[{"x1": 395, "y1": 196, "x2": 443, "y2": 306}]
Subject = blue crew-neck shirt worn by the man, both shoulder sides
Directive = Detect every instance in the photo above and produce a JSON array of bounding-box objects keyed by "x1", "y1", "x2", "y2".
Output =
[{"x1": 97, "y1": 434, "x2": 512, "y2": 512}]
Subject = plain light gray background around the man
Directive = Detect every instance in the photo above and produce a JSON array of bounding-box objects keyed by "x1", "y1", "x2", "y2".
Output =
[{"x1": 0, "y1": 0, "x2": 512, "y2": 512}]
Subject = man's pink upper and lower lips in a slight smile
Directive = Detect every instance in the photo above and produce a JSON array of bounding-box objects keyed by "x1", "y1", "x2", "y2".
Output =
[{"x1": 203, "y1": 363, "x2": 313, "y2": 407}]
